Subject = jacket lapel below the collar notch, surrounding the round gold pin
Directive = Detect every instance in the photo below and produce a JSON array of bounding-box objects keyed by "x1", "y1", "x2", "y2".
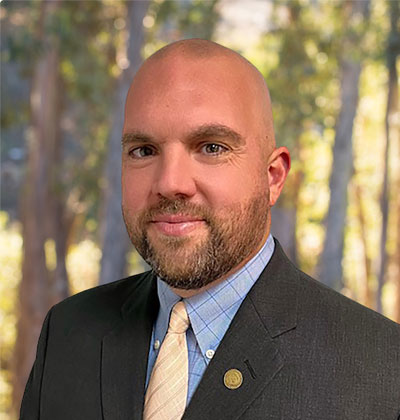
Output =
[{"x1": 183, "y1": 299, "x2": 283, "y2": 420}]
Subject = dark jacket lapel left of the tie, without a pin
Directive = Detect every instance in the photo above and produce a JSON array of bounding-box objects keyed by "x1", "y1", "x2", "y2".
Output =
[{"x1": 100, "y1": 274, "x2": 159, "y2": 420}]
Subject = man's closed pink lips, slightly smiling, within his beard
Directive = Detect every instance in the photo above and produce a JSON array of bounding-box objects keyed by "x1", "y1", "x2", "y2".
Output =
[{"x1": 150, "y1": 214, "x2": 206, "y2": 237}]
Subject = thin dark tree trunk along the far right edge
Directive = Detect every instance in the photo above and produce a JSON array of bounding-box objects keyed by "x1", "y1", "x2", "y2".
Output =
[{"x1": 376, "y1": 1, "x2": 399, "y2": 312}]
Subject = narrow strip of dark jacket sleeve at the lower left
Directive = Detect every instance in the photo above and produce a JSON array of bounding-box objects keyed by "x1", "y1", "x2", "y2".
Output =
[{"x1": 20, "y1": 309, "x2": 52, "y2": 420}]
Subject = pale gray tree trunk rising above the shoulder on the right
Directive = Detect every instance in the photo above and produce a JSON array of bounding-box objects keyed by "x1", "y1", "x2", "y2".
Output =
[{"x1": 318, "y1": 0, "x2": 369, "y2": 290}]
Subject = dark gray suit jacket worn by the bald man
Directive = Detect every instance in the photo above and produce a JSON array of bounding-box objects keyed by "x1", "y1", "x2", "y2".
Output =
[{"x1": 21, "y1": 243, "x2": 400, "y2": 420}]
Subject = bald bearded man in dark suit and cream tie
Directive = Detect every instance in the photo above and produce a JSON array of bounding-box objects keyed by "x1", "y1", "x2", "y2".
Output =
[{"x1": 21, "y1": 40, "x2": 400, "y2": 420}]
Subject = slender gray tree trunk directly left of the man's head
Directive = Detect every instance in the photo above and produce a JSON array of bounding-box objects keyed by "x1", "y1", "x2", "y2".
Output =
[{"x1": 99, "y1": 1, "x2": 149, "y2": 284}]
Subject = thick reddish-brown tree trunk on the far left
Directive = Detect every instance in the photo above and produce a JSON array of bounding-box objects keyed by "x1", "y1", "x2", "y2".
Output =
[{"x1": 13, "y1": 1, "x2": 68, "y2": 412}]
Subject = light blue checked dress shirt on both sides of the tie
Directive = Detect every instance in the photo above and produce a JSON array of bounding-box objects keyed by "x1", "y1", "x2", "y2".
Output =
[{"x1": 146, "y1": 235, "x2": 275, "y2": 404}]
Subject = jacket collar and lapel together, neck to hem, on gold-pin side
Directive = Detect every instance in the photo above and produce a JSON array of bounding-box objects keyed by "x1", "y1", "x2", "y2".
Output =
[{"x1": 183, "y1": 242, "x2": 298, "y2": 420}]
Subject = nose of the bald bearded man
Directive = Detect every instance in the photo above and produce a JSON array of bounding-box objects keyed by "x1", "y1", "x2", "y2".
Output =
[{"x1": 152, "y1": 147, "x2": 196, "y2": 199}]
